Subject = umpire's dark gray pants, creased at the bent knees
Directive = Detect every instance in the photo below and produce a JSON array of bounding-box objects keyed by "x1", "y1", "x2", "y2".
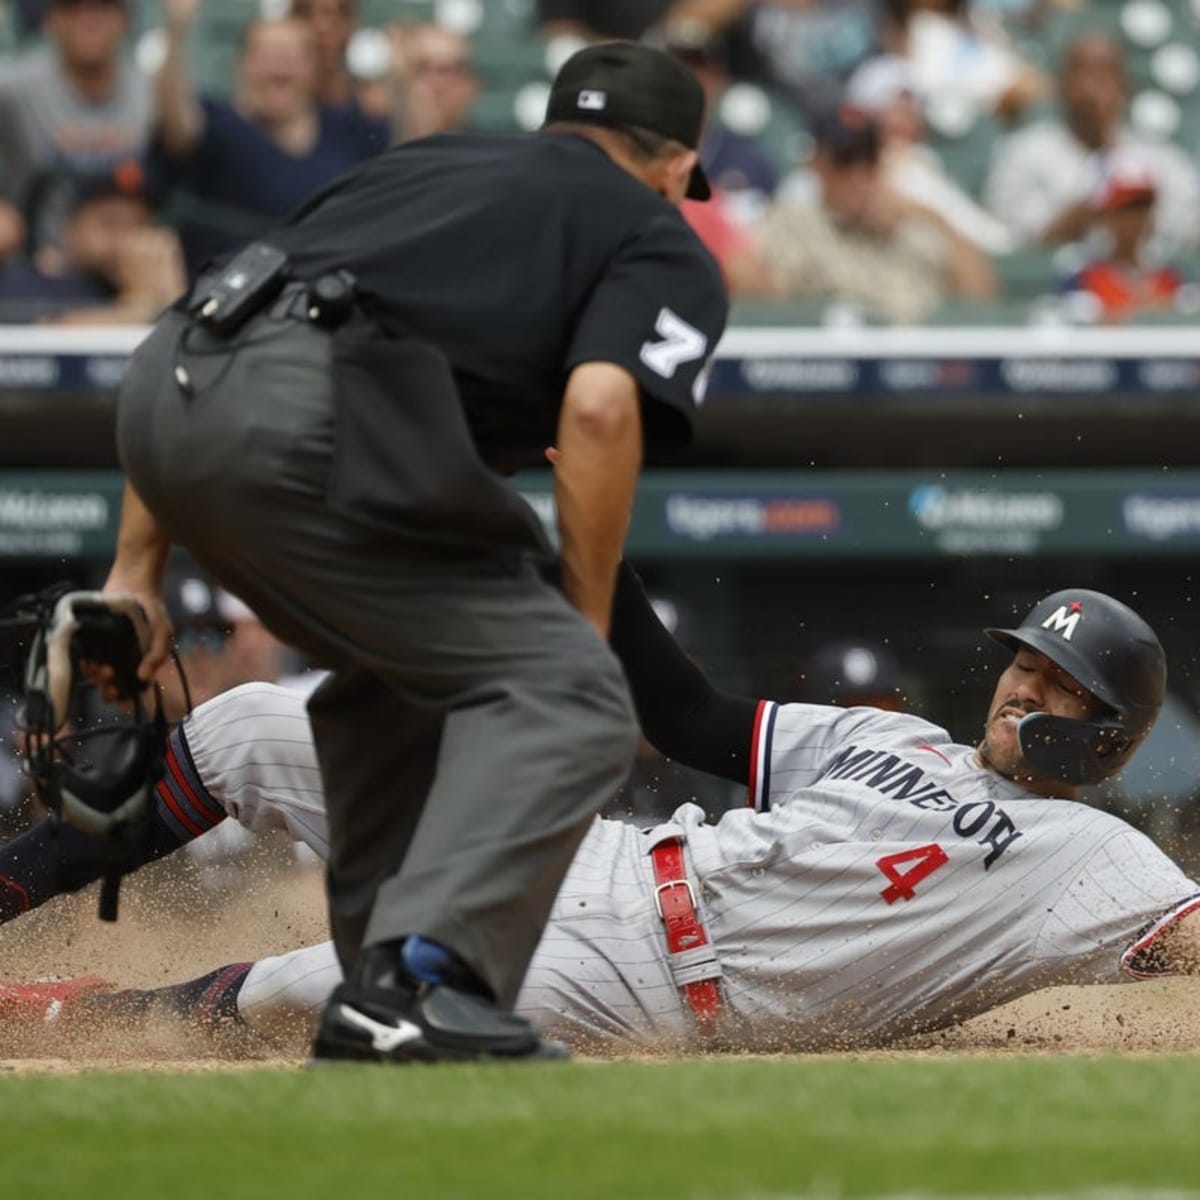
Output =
[{"x1": 118, "y1": 314, "x2": 635, "y2": 1004}]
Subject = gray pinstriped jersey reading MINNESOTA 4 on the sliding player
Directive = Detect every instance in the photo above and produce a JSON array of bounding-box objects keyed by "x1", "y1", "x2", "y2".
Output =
[{"x1": 667, "y1": 702, "x2": 1200, "y2": 1045}]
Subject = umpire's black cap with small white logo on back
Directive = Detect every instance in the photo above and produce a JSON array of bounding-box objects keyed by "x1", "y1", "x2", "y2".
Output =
[{"x1": 546, "y1": 42, "x2": 713, "y2": 200}]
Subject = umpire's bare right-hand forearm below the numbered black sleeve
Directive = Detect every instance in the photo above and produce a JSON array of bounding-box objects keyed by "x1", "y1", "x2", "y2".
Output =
[{"x1": 554, "y1": 362, "x2": 642, "y2": 637}]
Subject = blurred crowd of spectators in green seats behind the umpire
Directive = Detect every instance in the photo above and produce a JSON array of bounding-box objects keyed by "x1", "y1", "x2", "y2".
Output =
[{"x1": 0, "y1": 0, "x2": 1200, "y2": 324}]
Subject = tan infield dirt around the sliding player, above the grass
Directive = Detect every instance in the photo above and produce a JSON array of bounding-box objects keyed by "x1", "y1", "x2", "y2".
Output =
[{"x1": 0, "y1": 845, "x2": 1200, "y2": 1073}]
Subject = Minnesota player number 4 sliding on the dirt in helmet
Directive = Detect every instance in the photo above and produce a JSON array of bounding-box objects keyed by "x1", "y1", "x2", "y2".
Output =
[{"x1": 0, "y1": 571, "x2": 1200, "y2": 1049}]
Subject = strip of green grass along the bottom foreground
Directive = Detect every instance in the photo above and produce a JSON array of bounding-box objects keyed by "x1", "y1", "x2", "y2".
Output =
[{"x1": 0, "y1": 1056, "x2": 1200, "y2": 1200}]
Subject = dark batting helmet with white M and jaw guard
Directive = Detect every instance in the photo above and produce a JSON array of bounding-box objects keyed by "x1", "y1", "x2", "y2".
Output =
[{"x1": 984, "y1": 588, "x2": 1166, "y2": 785}]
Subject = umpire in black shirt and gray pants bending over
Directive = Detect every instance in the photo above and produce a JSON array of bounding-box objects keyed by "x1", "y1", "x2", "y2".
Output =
[{"x1": 98, "y1": 42, "x2": 726, "y2": 1061}]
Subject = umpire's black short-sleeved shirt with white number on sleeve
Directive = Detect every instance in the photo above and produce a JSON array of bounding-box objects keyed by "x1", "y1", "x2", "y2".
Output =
[{"x1": 270, "y1": 133, "x2": 727, "y2": 472}]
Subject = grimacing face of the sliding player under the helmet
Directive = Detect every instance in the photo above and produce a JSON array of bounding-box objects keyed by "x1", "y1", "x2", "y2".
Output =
[{"x1": 979, "y1": 648, "x2": 1100, "y2": 794}]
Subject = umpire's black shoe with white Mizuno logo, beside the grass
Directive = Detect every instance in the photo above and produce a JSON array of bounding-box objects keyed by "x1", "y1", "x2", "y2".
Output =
[{"x1": 312, "y1": 948, "x2": 570, "y2": 1062}]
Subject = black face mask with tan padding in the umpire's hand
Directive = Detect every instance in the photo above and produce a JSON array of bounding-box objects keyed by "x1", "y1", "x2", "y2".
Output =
[{"x1": 8, "y1": 588, "x2": 177, "y2": 920}]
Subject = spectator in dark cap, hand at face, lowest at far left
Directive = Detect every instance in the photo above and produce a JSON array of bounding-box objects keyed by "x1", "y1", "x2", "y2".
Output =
[{"x1": 0, "y1": 160, "x2": 185, "y2": 324}]
